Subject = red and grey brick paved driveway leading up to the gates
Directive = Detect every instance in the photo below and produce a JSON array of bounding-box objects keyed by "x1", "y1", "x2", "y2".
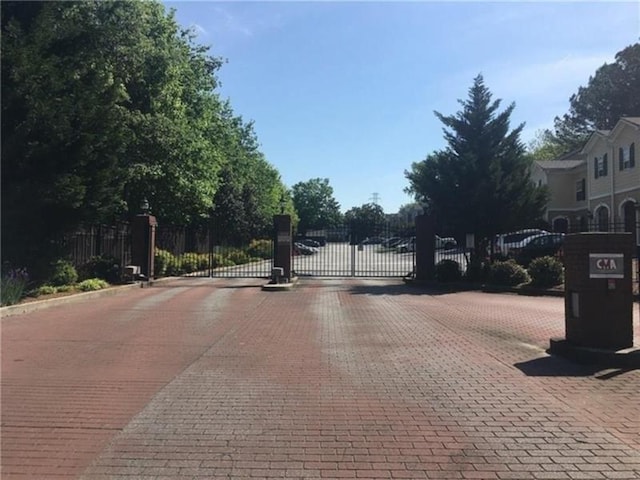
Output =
[{"x1": 0, "y1": 279, "x2": 640, "y2": 479}]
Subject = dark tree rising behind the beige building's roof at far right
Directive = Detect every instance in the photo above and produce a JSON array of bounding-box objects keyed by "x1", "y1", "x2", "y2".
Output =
[{"x1": 553, "y1": 43, "x2": 640, "y2": 153}]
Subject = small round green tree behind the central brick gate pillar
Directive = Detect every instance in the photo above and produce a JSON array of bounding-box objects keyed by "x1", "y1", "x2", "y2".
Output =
[{"x1": 291, "y1": 178, "x2": 342, "y2": 232}]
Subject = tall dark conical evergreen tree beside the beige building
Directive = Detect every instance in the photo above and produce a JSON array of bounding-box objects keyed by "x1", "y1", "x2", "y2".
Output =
[{"x1": 405, "y1": 75, "x2": 547, "y2": 248}]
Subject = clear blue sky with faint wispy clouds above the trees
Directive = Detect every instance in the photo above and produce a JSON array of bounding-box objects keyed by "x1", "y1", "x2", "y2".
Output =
[{"x1": 164, "y1": 1, "x2": 640, "y2": 213}]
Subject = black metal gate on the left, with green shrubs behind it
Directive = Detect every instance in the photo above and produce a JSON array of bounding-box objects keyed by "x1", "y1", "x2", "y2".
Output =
[{"x1": 154, "y1": 225, "x2": 273, "y2": 278}]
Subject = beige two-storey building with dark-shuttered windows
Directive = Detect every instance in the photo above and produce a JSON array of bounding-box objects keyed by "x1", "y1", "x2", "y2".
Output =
[{"x1": 531, "y1": 117, "x2": 640, "y2": 232}]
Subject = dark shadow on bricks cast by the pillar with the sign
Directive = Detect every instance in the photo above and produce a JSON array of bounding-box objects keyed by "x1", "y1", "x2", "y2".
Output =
[{"x1": 514, "y1": 355, "x2": 634, "y2": 380}]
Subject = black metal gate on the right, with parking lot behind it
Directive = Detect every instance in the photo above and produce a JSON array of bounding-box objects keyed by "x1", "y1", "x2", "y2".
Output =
[{"x1": 293, "y1": 223, "x2": 415, "y2": 277}]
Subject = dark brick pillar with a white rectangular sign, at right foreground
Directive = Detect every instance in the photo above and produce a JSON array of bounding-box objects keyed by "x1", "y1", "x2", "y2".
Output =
[{"x1": 563, "y1": 233, "x2": 635, "y2": 350}]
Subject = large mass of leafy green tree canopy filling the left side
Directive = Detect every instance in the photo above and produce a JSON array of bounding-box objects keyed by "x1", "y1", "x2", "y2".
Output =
[{"x1": 1, "y1": 1, "x2": 290, "y2": 278}]
